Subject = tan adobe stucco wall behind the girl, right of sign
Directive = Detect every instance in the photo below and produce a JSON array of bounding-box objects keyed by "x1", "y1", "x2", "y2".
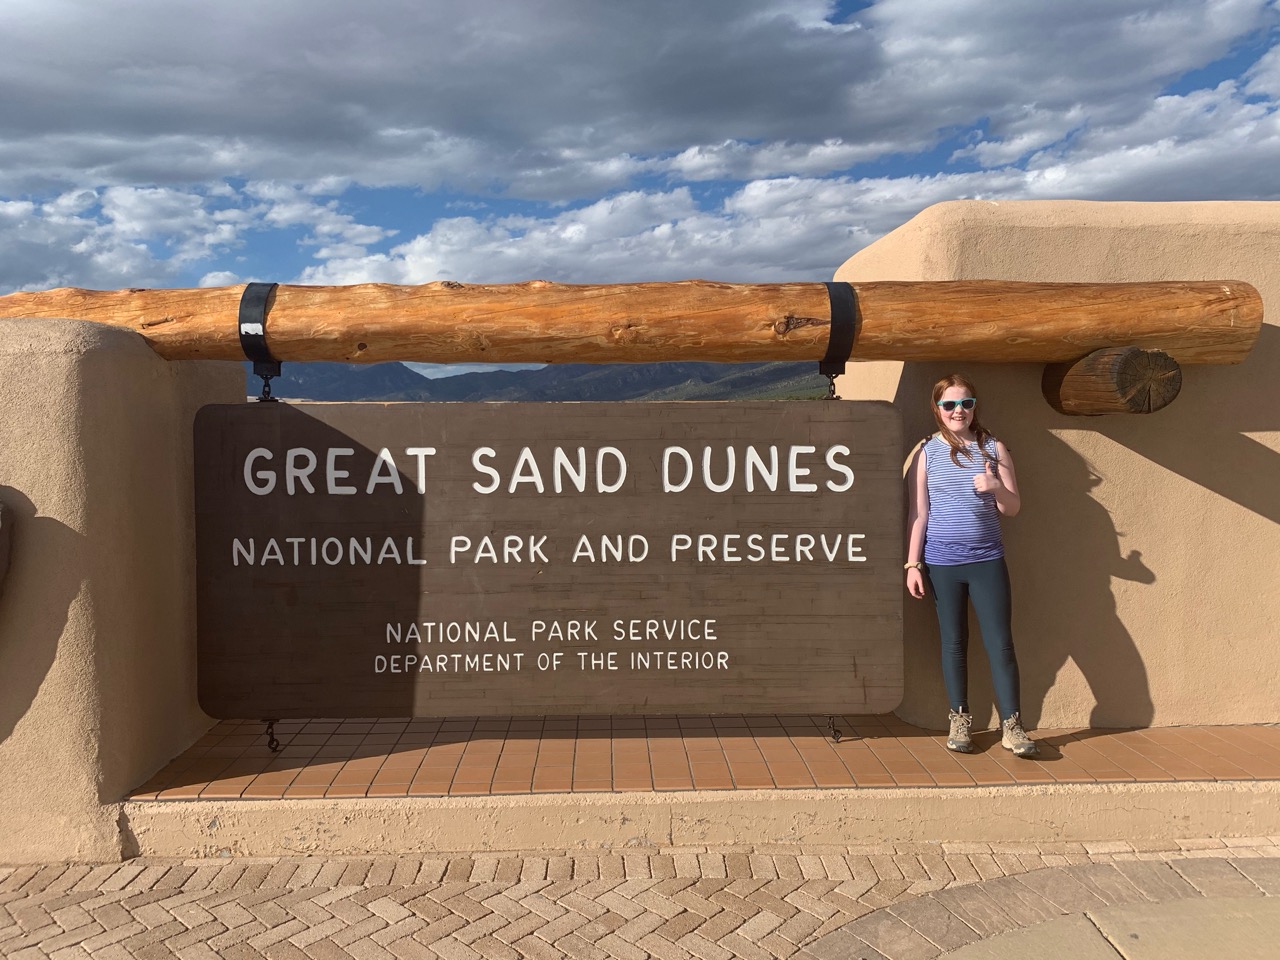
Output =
[{"x1": 836, "y1": 201, "x2": 1280, "y2": 727}]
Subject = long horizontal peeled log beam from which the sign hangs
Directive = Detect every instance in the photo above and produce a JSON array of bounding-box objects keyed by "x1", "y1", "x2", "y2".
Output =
[{"x1": 0, "y1": 280, "x2": 1262, "y2": 364}]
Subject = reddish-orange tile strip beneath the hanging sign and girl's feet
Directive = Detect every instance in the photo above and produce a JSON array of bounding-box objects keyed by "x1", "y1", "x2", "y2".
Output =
[{"x1": 129, "y1": 716, "x2": 1280, "y2": 800}]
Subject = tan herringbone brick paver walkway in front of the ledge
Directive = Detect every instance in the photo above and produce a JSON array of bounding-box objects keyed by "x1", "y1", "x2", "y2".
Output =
[{"x1": 0, "y1": 837, "x2": 1280, "y2": 960}]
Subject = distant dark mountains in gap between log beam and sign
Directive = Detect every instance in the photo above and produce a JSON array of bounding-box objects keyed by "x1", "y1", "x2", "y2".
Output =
[{"x1": 244, "y1": 361, "x2": 828, "y2": 402}]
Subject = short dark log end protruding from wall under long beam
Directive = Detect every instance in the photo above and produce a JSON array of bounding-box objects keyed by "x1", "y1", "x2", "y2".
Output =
[{"x1": 1041, "y1": 347, "x2": 1183, "y2": 416}]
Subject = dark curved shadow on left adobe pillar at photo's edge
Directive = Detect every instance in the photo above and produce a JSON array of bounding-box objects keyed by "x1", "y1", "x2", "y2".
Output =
[{"x1": 0, "y1": 486, "x2": 84, "y2": 742}]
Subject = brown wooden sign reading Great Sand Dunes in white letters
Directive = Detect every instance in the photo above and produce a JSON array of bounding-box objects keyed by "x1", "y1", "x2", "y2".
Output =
[{"x1": 195, "y1": 401, "x2": 902, "y2": 718}]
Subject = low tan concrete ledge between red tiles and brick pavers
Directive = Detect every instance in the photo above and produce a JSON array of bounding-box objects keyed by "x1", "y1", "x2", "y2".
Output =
[{"x1": 122, "y1": 781, "x2": 1280, "y2": 858}]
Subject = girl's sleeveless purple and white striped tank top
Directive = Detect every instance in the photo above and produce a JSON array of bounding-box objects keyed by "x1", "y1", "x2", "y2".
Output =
[{"x1": 924, "y1": 434, "x2": 1005, "y2": 567}]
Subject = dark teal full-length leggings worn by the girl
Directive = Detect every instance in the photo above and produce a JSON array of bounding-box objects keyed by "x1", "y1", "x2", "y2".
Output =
[{"x1": 924, "y1": 558, "x2": 1019, "y2": 721}]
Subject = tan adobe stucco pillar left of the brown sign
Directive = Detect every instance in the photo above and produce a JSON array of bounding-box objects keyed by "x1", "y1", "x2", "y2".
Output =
[{"x1": 0, "y1": 320, "x2": 244, "y2": 863}]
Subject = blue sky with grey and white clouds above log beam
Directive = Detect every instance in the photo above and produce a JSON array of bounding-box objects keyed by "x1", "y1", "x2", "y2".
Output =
[{"x1": 0, "y1": 0, "x2": 1280, "y2": 343}]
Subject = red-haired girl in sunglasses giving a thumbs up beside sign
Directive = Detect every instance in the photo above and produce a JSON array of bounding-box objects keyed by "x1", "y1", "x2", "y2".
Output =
[{"x1": 906, "y1": 374, "x2": 1039, "y2": 756}]
